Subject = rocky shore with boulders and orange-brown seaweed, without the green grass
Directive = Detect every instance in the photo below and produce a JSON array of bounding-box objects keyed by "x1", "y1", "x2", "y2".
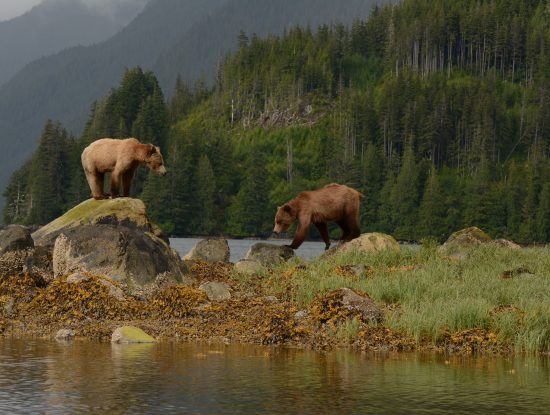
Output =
[{"x1": 0, "y1": 199, "x2": 545, "y2": 354}]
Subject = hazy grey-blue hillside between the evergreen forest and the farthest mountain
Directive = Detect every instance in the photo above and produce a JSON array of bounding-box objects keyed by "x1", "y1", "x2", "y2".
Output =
[{"x1": 0, "y1": 0, "x2": 392, "y2": 214}]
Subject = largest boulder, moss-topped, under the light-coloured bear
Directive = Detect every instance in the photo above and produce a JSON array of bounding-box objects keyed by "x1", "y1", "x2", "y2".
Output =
[{"x1": 33, "y1": 198, "x2": 189, "y2": 288}]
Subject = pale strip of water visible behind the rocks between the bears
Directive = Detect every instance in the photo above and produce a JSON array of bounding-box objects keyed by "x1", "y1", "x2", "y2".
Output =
[{"x1": 170, "y1": 238, "x2": 325, "y2": 262}]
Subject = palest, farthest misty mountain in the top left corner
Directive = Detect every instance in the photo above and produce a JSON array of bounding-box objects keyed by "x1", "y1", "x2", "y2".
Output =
[{"x1": 0, "y1": 0, "x2": 146, "y2": 85}]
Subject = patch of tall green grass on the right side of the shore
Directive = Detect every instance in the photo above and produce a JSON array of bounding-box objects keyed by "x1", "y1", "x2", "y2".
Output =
[{"x1": 257, "y1": 244, "x2": 550, "y2": 352}]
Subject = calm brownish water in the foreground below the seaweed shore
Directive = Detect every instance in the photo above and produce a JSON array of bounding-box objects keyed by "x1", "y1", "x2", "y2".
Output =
[{"x1": 0, "y1": 339, "x2": 550, "y2": 414}]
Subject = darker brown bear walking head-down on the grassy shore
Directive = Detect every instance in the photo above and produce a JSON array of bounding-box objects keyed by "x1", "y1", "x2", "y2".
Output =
[{"x1": 273, "y1": 183, "x2": 363, "y2": 250}]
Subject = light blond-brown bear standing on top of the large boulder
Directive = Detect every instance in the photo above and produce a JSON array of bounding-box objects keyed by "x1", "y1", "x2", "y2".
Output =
[{"x1": 81, "y1": 138, "x2": 166, "y2": 200}]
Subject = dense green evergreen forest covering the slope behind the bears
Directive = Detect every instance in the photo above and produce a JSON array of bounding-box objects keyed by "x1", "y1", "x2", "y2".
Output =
[{"x1": 4, "y1": 0, "x2": 550, "y2": 243}]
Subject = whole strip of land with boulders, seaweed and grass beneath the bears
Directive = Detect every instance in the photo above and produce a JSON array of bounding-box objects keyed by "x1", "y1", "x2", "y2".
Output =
[{"x1": 0, "y1": 198, "x2": 550, "y2": 354}]
